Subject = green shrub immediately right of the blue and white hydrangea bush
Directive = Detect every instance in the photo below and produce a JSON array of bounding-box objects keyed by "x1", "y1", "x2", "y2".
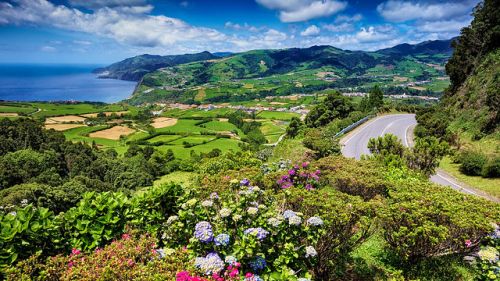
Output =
[{"x1": 278, "y1": 187, "x2": 374, "y2": 280}]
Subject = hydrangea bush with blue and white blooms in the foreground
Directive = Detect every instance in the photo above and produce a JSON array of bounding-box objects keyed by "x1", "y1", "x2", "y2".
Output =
[{"x1": 162, "y1": 179, "x2": 323, "y2": 281}]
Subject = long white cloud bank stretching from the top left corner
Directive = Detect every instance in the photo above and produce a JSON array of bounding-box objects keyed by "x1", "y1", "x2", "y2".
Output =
[{"x1": 0, "y1": 0, "x2": 225, "y2": 47}]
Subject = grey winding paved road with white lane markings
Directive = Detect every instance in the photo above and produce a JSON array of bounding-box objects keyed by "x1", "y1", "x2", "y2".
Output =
[{"x1": 340, "y1": 114, "x2": 496, "y2": 201}]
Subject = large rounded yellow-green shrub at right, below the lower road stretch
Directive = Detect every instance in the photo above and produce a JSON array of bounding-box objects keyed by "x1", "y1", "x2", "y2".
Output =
[{"x1": 379, "y1": 175, "x2": 500, "y2": 261}]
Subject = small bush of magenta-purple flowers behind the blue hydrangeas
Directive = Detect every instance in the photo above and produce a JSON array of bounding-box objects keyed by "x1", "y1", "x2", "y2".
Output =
[{"x1": 276, "y1": 162, "x2": 321, "y2": 190}]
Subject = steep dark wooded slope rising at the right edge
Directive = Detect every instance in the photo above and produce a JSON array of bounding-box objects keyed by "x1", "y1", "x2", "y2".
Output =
[{"x1": 416, "y1": 0, "x2": 500, "y2": 184}]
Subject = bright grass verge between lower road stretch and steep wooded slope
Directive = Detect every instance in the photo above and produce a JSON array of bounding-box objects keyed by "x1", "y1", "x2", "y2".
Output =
[{"x1": 439, "y1": 157, "x2": 500, "y2": 198}]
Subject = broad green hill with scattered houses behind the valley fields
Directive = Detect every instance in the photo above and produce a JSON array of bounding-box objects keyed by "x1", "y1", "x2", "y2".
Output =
[{"x1": 130, "y1": 40, "x2": 452, "y2": 103}]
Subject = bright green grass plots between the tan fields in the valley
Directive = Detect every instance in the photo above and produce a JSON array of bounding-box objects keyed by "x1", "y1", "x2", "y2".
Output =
[{"x1": 0, "y1": 100, "x2": 296, "y2": 158}]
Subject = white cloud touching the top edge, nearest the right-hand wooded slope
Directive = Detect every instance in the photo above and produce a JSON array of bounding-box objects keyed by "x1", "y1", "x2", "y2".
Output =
[{"x1": 377, "y1": 0, "x2": 478, "y2": 22}]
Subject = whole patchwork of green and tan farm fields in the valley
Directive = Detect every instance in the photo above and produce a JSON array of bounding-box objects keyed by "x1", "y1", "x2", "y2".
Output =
[{"x1": 0, "y1": 98, "x2": 294, "y2": 159}]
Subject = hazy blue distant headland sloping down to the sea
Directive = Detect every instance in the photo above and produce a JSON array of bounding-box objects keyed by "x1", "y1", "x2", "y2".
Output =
[{"x1": 93, "y1": 51, "x2": 220, "y2": 81}]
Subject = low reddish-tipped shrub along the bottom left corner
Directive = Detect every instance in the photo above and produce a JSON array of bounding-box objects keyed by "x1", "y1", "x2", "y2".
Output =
[{"x1": 6, "y1": 234, "x2": 190, "y2": 281}]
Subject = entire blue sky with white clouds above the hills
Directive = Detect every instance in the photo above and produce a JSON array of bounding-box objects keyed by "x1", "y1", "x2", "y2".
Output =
[{"x1": 0, "y1": 0, "x2": 479, "y2": 64}]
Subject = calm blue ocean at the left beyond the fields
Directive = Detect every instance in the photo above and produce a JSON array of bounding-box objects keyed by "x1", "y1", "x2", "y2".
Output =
[{"x1": 0, "y1": 64, "x2": 136, "y2": 103}]
